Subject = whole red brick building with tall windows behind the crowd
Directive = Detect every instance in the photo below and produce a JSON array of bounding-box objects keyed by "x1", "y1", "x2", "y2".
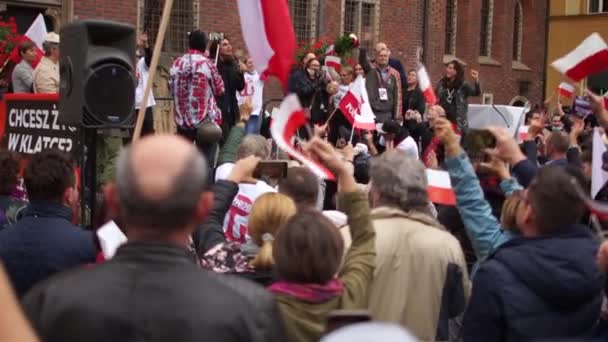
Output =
[{"x1": 0, "y1": 0, "x2": 548, "y2": 104}]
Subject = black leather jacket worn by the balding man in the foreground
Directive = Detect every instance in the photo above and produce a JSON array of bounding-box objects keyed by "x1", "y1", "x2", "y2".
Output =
[{"x1": 23, "y1": 242, "x2": 285, "y2": 342}]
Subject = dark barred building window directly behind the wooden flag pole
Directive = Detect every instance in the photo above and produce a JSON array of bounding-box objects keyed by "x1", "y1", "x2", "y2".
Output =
[{"x1": 142, "y1": 0, "x2": 198, "y2": 53}]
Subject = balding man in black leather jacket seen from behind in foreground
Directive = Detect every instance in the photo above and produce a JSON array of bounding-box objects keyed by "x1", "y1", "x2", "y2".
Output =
[{"x1": 23, "y1": 135, "x2": 284, "y2": 342}]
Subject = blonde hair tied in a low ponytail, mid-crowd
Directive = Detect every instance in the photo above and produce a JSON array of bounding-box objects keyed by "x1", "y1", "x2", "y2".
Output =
[{"x1": 247, "y1": 193, "x2": 297, "y2": 269}]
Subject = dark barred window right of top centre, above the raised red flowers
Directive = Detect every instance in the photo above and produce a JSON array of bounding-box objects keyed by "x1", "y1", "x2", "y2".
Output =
[{"x1": 342, "y1": 0, "x2": 378, "y2": 49}]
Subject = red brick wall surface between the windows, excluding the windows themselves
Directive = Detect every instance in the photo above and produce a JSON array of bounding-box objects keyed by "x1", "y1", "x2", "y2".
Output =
[{"x1": 74, "y1": 0, "x2": 547, "y2": 104}]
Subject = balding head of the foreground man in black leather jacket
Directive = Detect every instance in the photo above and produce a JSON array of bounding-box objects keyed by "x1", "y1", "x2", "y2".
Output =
[{"x1": 109, "y1": 135, "x2": 208, "y2": 234}]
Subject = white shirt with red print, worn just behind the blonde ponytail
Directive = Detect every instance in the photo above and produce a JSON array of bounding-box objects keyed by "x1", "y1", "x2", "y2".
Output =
[{"x1": 215, "y1": 163, "x2": 277, "y2": 243}]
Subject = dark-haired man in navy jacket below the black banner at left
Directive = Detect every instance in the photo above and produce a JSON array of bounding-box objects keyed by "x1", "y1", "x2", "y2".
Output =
[{"x1": 0, "y1": 150, "x2": 97, "y2": 297}]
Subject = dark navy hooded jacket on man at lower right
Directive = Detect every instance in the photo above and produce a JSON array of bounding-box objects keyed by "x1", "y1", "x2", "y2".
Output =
[{"x1": 464, "y1": 225, "x2": 604, "y2": 341}]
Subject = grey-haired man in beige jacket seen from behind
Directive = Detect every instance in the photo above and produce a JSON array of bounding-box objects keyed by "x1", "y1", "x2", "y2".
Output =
[{"x1": 341, "y1": 151, "x2": 471, "y2": 341}]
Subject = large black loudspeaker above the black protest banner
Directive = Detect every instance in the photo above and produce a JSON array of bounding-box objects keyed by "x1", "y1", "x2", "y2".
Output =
[{"x1": 58, "y1": 20, "x2": 136, "y2": 128}]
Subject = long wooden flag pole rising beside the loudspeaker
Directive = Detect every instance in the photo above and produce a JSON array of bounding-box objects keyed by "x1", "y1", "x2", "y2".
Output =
[{"x1": 133, "y1": 0, "x2": 173, "y2": 142}]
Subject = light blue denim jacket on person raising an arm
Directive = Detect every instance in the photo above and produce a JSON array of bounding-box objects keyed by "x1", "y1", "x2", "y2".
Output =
[{"x1": 445, "y1": 152, "x2": 521, "y2": 263}]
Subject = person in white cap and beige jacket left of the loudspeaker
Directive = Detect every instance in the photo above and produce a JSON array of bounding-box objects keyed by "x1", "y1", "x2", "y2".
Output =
[{"x1": 34, "y1": 32, "x2": 59, "y2": 94}]
